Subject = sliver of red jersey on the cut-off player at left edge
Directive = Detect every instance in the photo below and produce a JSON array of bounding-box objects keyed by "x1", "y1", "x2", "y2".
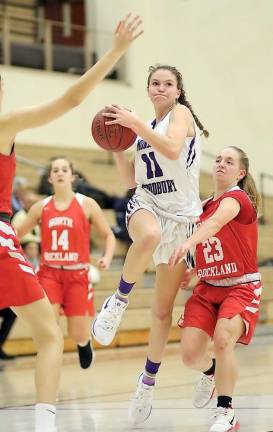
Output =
[{"x1": 0, "y1": 149, "x2": 16, "y2": 215}]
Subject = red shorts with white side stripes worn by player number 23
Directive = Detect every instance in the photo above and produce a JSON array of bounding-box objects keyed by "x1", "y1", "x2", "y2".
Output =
[{"x1": 178, "y1": 281, "x2": 262, "y2": 345}]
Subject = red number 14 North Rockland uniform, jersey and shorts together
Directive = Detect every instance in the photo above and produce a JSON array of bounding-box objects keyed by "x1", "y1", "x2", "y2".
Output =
[{"x1": 38, "y1": 194, "x2": 95, "y2": 316}]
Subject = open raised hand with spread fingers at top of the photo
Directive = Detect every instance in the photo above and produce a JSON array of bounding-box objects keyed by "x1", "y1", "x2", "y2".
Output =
[{"x1": 113, "y1": 14, "x2": 143, "y2": 52}]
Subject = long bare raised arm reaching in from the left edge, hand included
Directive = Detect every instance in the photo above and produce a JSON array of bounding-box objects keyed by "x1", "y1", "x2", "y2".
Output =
[{"x1": 0, "y1": 15, "x2": 142, "y2": 151}]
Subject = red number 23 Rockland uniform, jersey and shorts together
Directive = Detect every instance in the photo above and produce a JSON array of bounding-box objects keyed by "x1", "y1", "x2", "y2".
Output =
[{"x1": 180, "y1": 187, "x2": 262, "y2": 344}]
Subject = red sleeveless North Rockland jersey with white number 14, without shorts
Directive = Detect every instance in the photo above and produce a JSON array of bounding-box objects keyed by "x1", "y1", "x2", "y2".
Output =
[{"x1": 41, "y1": 193, "x2": 90, "y2": 265}]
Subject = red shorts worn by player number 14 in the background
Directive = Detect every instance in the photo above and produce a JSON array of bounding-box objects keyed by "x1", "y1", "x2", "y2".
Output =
[{"x1": 37, "y1": 265, "x2": 95, "y2": 317}]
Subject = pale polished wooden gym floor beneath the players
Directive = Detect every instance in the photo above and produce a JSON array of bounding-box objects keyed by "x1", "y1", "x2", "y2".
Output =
[{"x1": 0, "y1": 326, "x2": 273, "y2": 432}]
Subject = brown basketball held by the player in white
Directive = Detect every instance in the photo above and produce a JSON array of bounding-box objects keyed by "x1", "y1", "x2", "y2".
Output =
[{"x1": 91, "y1": 108, "x2": 137, "y2": 152}]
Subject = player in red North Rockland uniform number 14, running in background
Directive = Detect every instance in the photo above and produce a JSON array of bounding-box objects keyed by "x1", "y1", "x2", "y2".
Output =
[{"x1": 17, "y1": 157, "x2": 115, "y2": 369}]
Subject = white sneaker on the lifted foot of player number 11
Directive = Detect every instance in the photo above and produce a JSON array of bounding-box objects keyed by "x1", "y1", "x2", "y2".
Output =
[{"x1": 92, "y1": 294, "x2": 128, "y2": 345}]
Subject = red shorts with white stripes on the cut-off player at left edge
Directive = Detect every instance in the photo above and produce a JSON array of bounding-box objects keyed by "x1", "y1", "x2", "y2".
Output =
[{"x1": 0, "y1": 221, "x2": 45, "y2": 309}]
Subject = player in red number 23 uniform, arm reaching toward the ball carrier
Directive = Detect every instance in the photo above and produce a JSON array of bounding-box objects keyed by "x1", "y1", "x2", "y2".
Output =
[{"x1": 169, "y1": 147, "x2": 262, "y2": 432}]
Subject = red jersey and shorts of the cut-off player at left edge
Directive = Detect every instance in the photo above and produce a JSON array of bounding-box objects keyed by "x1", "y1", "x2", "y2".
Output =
[{"x1": 0, "y1": 148, "x2": 45, "y2": 309}]
